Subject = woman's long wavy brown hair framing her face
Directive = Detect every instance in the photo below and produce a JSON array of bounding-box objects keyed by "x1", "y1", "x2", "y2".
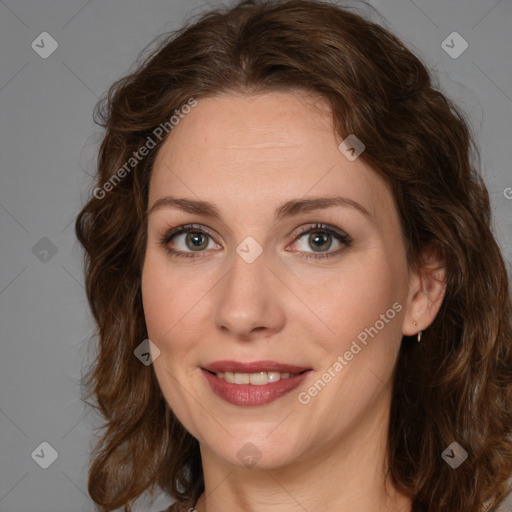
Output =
[{"x1": 75, "y1": 0, "x2": 512, "y2": 512}]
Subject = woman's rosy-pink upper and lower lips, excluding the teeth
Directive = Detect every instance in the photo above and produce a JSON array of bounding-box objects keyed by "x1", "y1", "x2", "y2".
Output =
[{"x1": 201, "y1": 361, "x2": 312, "y2": 407}]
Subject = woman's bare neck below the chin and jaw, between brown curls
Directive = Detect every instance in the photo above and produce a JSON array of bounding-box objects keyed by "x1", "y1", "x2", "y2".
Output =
[{"x1": 195, "y1": 396, "x2": 412, "y2": 512}]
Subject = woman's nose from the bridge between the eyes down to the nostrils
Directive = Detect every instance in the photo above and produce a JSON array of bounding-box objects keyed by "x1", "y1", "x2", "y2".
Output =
[{"x1": 214, "y1": 244, "x2": 284, "y2": 338}]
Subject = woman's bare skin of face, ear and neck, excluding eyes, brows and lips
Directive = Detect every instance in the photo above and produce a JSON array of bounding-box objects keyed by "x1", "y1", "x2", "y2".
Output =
[{"x1": 142, "y1": 91, "x2": 444, "y2": 512}]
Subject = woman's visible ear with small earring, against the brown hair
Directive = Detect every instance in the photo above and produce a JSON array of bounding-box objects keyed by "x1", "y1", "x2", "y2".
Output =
[{"x1": 402, "y1": 252, "x2": 446, "y2": 336}]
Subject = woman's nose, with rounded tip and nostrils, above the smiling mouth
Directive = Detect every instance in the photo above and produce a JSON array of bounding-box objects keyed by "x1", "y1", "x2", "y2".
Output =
[{"x1": 213, "y1": 247, "x2": 286, "y2": 341}]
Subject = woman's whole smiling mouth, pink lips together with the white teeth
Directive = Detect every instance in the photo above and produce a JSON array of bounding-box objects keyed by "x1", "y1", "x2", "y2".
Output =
[{"x1": 201, "y1": 361, "x2": 312, "y2": 406}]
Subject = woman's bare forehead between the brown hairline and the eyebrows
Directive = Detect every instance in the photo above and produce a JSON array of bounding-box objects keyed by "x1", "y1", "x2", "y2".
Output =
[{"x1": 149, "y1": 92, "x2": 392, "y2": 224}]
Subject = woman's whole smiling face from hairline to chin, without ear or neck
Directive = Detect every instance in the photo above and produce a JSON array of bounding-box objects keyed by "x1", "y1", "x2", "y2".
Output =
[{"x1": 142, "y1": 92, "x2": 409, "y2": 468}]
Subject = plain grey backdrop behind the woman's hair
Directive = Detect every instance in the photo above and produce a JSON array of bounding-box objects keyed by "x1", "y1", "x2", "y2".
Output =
[{"x1": 0, "y1": 0, "x2": 512, "y2": 512}]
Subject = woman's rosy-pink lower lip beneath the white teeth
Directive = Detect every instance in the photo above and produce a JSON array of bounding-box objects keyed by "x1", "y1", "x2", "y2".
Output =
[{"x1": 202, "y1": 370, "x2": 310, "y2": 406}]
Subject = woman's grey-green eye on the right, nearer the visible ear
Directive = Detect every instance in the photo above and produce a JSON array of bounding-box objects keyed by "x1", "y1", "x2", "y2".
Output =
[{"x1": 287, "y1": 224, "x2": 352, "y2": 259}]
